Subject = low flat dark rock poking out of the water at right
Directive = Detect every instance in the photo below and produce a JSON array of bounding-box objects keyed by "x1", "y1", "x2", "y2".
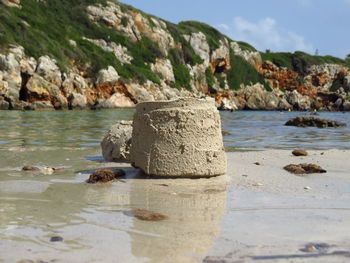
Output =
[{"x1": 285, "y1": 117, "x2": 346, "y2": 128}]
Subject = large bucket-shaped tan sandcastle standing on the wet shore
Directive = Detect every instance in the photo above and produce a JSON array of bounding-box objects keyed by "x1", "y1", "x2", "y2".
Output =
[{"x1": 131, "y1": 99, "x2": 227, "y2": 177}]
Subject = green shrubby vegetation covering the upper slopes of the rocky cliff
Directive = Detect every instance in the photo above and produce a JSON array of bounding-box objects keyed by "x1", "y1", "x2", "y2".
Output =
[{"x1": 0, "y1": 0, "x2": 350, "y2": 93}]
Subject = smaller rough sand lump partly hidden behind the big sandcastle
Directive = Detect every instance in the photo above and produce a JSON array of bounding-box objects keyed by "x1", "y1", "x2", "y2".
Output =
[{"x1": 101, "y1": 121, "x2": 132, "y2": 162}]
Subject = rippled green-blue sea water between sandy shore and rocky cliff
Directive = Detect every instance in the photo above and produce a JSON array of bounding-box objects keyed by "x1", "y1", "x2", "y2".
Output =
[{"x1": 0, "y1": 110, "x2": 350, "y2": 151}]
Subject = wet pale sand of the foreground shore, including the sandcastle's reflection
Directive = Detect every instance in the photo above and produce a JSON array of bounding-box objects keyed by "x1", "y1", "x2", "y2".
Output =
[{"x1": 0, "y1": 150, "x2": 350, "y2": 263}]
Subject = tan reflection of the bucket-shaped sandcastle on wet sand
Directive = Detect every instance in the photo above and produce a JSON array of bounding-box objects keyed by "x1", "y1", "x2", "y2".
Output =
[{"x1": 129, "y1": 176, "x2": 226, "y2": 263}]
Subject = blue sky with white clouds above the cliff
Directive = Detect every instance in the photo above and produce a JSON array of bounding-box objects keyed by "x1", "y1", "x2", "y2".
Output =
[{"x1": 121, "y1": 0, "x2": 350, "y2": 58}]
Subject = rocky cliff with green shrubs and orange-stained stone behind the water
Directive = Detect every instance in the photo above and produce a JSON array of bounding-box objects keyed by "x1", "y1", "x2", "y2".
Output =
[{"x1": 0, "y1": 0, "x2": 350, "y2": 110}]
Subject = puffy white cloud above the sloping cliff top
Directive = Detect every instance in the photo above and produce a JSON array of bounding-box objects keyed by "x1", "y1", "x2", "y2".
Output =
[{"x1": 218, "y1": 16, "x2": 314, "y2": 53}]
